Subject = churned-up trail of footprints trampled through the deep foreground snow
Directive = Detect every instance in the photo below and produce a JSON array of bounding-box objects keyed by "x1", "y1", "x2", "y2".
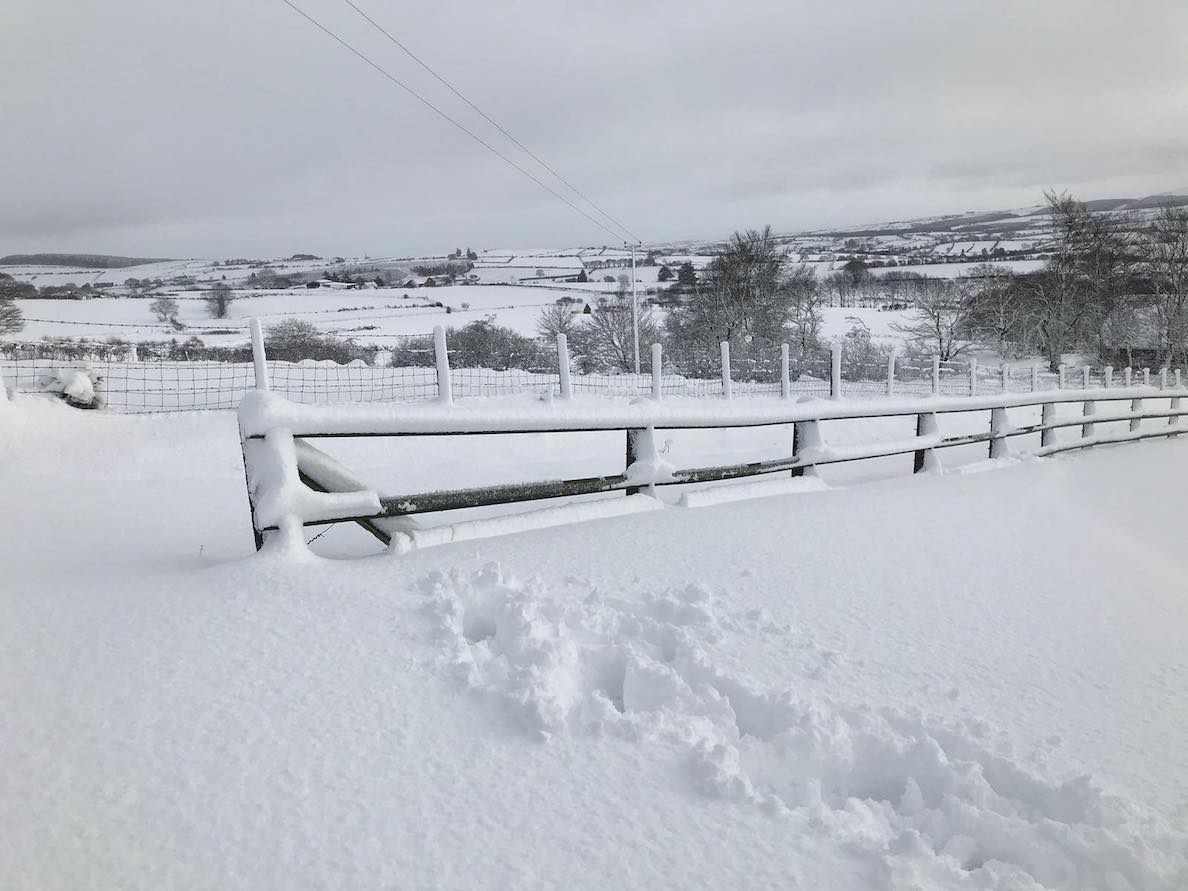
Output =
[{"x1": 421, "y1": 565, "x2": 1188, "y2": 890}]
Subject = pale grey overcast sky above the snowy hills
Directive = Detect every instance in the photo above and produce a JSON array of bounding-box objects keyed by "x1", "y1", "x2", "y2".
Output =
[{"x1": 0, "y1": 0, "x2": 1188, "y2": 257}]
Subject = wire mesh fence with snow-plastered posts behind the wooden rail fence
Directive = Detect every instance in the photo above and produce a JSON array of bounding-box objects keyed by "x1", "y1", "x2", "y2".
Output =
[{"x1": 0, "y1": 320, "x2": 1181, "y2": 412}]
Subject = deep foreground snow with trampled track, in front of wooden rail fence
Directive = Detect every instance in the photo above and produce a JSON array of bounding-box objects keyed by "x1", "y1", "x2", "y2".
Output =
[{"x1": 0, "y1": 402, "x2": 1188, "y2": 889}]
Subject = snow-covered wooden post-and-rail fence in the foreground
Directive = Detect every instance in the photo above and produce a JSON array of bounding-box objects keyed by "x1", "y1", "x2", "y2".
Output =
[{"x1": 239, "y1": 351, "x2": 1188, "y2": 550}]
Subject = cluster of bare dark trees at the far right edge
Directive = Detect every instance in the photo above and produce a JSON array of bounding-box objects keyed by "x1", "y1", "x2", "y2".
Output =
[{"x1": 897, "y1": 194, "x2": 1188, "y2": 371}]
